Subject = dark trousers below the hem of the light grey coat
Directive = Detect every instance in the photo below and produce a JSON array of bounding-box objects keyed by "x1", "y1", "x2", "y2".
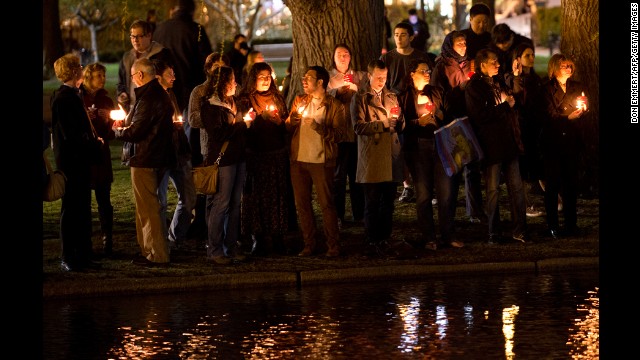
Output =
[{"x1": 362, "y1": 181, "x2": 398, "y2": 244}]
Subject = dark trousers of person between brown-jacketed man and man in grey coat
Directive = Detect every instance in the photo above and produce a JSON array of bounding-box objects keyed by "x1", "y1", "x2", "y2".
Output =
[{"x1": 333, "y1": 142, "x2": 364, "y2": 221}]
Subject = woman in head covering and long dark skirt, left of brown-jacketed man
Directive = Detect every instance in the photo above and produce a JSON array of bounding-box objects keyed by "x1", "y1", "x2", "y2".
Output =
[{"x1": 238, "y1": 62, "x2": 293, "y2": 255}]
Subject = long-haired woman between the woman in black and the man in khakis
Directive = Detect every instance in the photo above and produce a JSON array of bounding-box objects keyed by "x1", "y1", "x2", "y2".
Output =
[{"x1": 80, "y1": 63, "x2": 115, "y2": 256}]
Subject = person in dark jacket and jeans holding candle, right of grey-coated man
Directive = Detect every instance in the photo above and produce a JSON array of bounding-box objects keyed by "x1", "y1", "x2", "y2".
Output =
[{"x1": 398, "y1": 59, "x2": 464, "y2": 250}]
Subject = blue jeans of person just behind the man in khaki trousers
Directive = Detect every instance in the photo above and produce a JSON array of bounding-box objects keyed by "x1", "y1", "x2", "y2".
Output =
[{"x1": 158, "y1": 161, "x2": 196, "y2": 244}]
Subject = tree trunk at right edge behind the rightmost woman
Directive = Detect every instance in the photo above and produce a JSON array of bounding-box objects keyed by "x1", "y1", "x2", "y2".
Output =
[{"x1": 560, "y1": 0, "x2": 600, "y2": 196}]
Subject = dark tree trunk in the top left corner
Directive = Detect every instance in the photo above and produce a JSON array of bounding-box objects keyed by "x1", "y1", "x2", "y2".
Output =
[{"x1": 42, "y1": 0, "x2": 64, "y2": 80}]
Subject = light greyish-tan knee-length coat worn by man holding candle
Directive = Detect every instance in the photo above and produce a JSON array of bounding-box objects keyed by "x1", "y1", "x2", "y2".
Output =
[{"x1": 350, "y1": 85, "x2": 405, "y2": 183}]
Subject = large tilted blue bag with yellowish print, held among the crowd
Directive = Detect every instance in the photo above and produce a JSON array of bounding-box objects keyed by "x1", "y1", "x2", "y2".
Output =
[{"x1": 433, "y1": 116, "x2": 484, "y2": 176}]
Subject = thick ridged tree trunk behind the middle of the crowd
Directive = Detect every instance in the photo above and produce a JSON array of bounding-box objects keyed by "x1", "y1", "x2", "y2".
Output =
[{"x1": 284, "y1": 0, "x2": 384, "y2": 103}]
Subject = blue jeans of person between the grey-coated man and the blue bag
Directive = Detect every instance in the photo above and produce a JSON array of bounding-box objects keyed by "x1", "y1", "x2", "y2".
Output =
[{"x1": 405, "y1": 139, "x2": 458, "y2": 244}]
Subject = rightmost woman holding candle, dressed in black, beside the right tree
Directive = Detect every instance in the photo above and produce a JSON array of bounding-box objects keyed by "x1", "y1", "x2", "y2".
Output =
[{"x1": 540, "y1": 54, "x2": 586, "y2": 239}]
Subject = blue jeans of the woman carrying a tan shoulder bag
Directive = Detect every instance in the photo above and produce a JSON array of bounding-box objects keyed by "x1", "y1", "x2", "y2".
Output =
[{"x1": 206, "y1": 162, "x2": 247, "y2": 258}]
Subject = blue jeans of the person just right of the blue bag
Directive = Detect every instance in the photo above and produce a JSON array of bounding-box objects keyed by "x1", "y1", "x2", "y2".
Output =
[{"x1": 484, "y1": 158, "x2": 527, "y2": 236}]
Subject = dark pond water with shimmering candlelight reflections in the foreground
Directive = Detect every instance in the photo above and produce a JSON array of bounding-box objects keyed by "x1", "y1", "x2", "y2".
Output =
[{"x1": 43, "y1": 271, "x2": 599, "y2": 359}]
